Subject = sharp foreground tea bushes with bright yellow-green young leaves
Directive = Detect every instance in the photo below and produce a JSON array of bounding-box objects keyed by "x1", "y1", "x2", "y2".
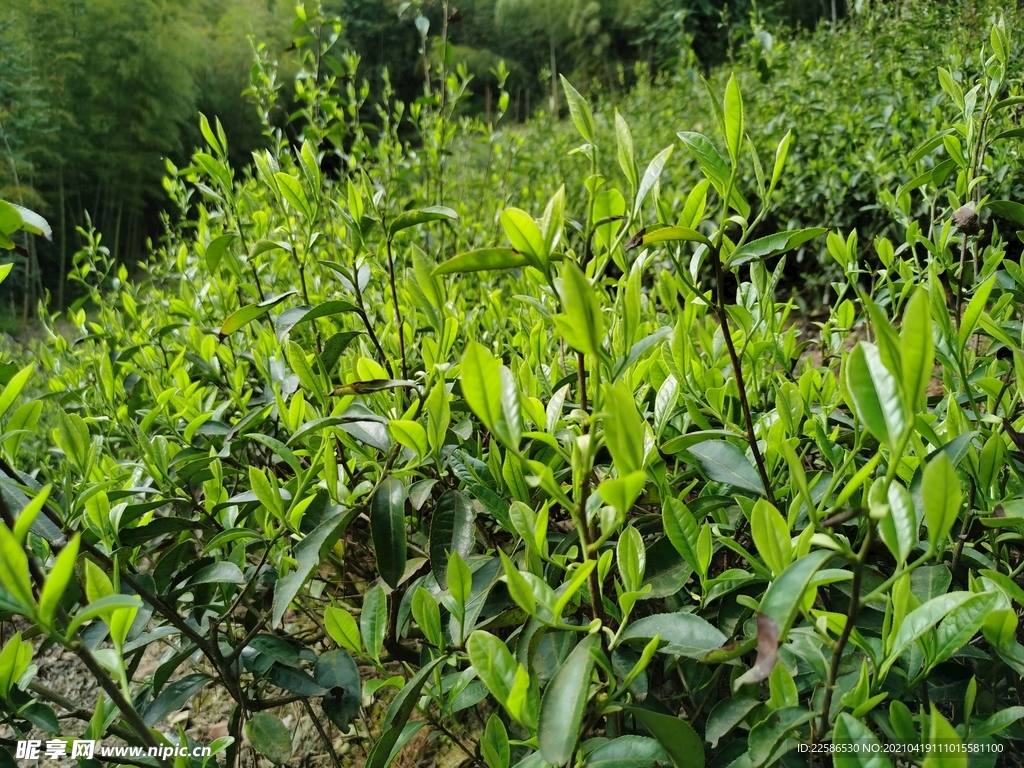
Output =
[{"x1": 0, "y1": 1, "x2": 1024, "y2": 768}]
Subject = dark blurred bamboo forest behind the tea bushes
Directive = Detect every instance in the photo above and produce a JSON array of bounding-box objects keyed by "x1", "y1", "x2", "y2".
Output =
[{"x1": 0, "y1": 0, "x2": 847, "y2": 325}]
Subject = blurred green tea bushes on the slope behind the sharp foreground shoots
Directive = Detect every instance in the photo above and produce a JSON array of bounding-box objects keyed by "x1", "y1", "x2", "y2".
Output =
[{"x1": 487, "y1": 3, "x2": 1024, "y2": 312}]
